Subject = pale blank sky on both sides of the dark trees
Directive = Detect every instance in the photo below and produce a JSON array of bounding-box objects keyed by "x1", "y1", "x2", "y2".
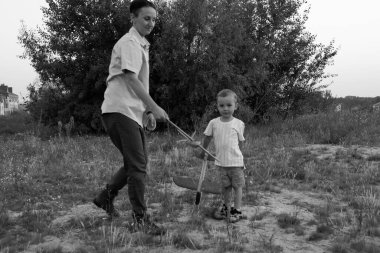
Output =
[{"x1": 0, "y1": 0, "x2": 380, "y2": 101}]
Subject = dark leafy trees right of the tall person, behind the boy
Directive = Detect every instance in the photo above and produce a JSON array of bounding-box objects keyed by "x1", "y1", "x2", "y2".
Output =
[{"x1": 153, "y1": 0, "x2": 336, "y2": 125}]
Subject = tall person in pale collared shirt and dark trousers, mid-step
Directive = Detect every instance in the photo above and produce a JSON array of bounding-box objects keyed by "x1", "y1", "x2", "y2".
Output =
[{"x1": 93, "y1": 0, "x2": 169, "y2": 235}]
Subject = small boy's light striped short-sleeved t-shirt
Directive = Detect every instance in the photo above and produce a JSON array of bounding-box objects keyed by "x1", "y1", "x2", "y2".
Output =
[{"x1": 204, "y1": 117, "x2": 245, "y2": 167}]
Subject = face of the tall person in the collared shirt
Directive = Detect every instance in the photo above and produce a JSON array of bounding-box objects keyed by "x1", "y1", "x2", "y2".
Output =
[{"x1": 131, "y1": 7, "x2": 157, "y2": 37}]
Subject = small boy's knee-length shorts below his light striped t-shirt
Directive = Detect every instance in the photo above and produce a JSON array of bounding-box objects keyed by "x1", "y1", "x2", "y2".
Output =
[{"x1": 218, "y1": 166, "x2": 245, "y2": 188}]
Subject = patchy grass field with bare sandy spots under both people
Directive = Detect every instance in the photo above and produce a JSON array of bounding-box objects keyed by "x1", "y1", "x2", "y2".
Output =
[{"x1": 0, "y1": 113, "x2": 380, "y2": 253}]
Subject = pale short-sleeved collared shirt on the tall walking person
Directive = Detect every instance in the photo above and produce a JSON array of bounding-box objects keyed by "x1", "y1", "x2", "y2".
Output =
[{"x1": 102, "y1": 27, "x2": 149, "y2": 126}]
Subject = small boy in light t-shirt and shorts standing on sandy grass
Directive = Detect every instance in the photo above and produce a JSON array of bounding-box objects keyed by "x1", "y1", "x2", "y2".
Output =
[{"x1": 197, "y1": 89, "x2": 245, "y2": 222}]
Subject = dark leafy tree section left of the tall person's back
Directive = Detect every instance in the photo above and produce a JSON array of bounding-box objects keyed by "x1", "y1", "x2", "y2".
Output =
[{"x1": 19, "y1": 0, "x2": 131, "y2": 130}]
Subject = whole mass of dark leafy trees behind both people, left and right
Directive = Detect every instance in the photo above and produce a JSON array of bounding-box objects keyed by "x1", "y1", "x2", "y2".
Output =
[{"x1": 19, "y1": 0, "x2": 337, "y2": 131}]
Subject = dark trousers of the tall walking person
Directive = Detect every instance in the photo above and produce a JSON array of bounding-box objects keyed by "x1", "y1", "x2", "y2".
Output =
[{"x1": 94, "y1": 113, "x2": 147, "y2": 217}]
